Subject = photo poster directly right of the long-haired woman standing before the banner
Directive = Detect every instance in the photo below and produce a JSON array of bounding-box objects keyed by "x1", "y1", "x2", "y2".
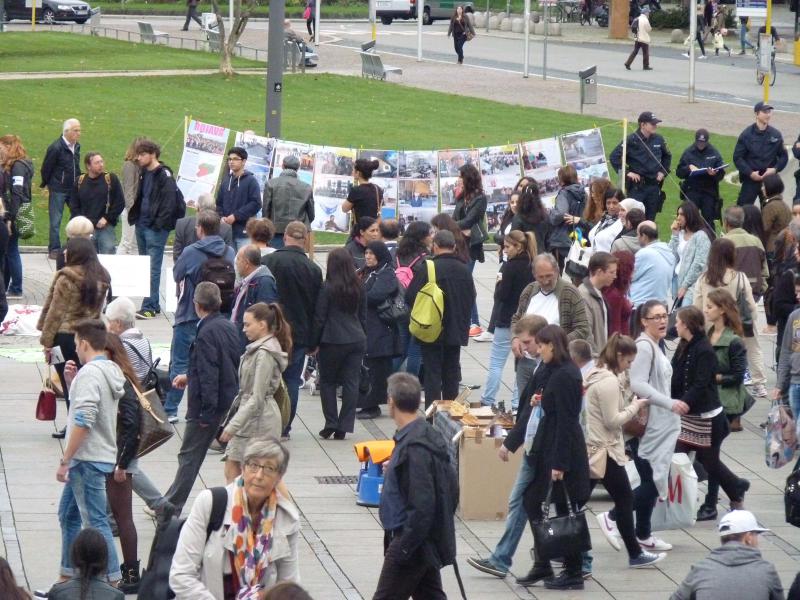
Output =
[{"x1": 478, "y1": 144, "x2": 522, "y2": 231}]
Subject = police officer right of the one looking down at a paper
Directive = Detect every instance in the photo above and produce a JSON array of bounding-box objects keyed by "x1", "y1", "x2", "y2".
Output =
[{"x1": 733, "y1": 102, "x2": 789, "y2": 206}]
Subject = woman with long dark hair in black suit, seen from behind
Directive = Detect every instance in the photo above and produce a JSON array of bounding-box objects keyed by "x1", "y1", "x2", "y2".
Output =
[{"x1": 311, "y1": 248, "x2": 367, "y2": 440}]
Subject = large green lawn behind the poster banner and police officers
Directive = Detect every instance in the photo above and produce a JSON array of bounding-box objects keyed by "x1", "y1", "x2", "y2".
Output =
[{"x1": 0, "y1": 55, "x2": 736, "y2": 244}]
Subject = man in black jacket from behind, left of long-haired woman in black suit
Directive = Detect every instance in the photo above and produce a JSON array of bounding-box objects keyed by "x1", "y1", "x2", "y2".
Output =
[{"x1": 261, "y1": 221, "x2": 322, "y2": 437}]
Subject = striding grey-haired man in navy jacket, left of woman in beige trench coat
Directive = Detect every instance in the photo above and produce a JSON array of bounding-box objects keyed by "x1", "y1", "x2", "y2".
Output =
[{"x1": 157, "y1": 281, "x2": 241, "y2": 521}]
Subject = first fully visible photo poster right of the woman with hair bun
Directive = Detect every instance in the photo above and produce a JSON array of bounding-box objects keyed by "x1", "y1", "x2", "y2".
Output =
[{"x1": 397, "y1": 150, "x2": 439, "y2": 231}]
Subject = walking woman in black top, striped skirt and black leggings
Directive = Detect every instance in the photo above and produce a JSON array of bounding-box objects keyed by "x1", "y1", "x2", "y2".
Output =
[{"x1": 671, "y1": 306, "x2": 750, "y2": 509}]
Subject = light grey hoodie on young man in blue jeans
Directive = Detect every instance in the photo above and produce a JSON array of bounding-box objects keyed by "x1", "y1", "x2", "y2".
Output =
[{"x1": 67, "y1": 358, "x2": 125, "y2": 465}]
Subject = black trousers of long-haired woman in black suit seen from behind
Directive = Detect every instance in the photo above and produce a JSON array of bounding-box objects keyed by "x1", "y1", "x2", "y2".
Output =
[{"x1": 319, "y1": 342, "x2": 365, "y2": 433}]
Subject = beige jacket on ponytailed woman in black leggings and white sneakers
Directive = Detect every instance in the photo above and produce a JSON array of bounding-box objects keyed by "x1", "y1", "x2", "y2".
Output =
[{"x1": 584, "y1": 367, "x2": 637, "y2": 466}]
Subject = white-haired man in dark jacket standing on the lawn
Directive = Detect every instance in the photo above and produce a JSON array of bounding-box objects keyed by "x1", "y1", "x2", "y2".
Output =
[{"x1": 39, "y1": 119, "x2": 81, "y2": 260}]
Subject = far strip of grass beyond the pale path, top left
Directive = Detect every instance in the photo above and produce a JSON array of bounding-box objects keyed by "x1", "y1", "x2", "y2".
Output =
[{"x1": 0, "y1": 31, "x2": 263, "y2": 72}]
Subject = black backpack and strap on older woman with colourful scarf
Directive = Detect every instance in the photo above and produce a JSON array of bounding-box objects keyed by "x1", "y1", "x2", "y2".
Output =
[{"x1": 139, "y1": 487, "x2": 228, "y2": 600}]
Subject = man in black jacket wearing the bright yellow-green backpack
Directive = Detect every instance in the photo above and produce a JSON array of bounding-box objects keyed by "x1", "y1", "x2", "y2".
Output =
[{"x1": 406, "y1": 229, "x2": 476, "y2": 407}]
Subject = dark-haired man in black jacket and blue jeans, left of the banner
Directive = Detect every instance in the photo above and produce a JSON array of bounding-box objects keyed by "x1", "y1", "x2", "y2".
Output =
[{"x1": 128, "y1": 140, "x2": 186, "y2": 319}]
